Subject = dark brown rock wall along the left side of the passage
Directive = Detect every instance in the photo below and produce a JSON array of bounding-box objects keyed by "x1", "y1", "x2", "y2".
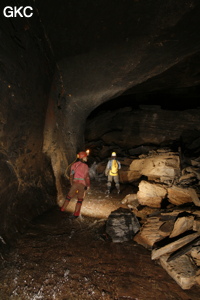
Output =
[{"x1": 0, "y1": 1, "x2": 56, "y2": 246}]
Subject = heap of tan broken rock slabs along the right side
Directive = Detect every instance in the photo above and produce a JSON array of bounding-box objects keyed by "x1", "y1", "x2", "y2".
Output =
[{"x1": 120, "y1": 150, "x2": 200, "y2": 289}]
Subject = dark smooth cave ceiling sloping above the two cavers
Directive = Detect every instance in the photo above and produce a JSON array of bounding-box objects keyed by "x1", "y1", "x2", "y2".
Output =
[{"x1": 35, "y1": 0, "x2": 200, "y2": 111}]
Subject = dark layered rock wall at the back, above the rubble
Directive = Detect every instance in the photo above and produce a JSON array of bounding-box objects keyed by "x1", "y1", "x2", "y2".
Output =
[{"x1": 85, "y1": 106, "x2": 200, "y2": 149}]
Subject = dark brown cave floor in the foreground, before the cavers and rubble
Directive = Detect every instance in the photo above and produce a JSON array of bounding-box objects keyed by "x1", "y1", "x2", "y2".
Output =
[{"x1": 0, "y1": 183, "x2": 200, "y2": 300}]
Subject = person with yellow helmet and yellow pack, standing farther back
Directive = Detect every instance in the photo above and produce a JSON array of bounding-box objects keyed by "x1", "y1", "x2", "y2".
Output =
[{"x1": 105, "y1": 152, "x2": 121, "y2": 194}]
